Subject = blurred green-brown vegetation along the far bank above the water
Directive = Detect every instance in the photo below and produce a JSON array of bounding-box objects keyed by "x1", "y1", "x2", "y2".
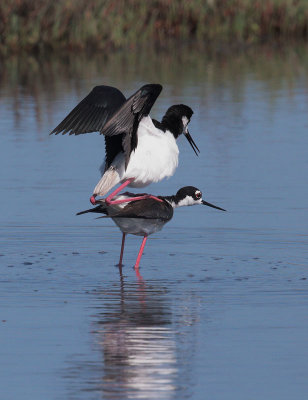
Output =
[{"x1": 0, "y1": 0, "x2": 308, "y2": 54}]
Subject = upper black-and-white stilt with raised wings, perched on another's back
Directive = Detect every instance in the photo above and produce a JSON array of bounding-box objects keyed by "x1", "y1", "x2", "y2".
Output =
[{"x1": 51, "y1": 84, "x2": 199, "y2": 204}]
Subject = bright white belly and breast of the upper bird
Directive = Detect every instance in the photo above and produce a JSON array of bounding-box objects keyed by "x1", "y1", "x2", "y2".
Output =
[{"x1": 119, "y1": 116, "x2": 179, "y2": 187}]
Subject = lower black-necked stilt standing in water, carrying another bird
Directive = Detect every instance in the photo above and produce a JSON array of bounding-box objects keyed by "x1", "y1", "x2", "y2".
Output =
[{"x1": 77, "y1": 186, "x2": 226, "y2": 268}]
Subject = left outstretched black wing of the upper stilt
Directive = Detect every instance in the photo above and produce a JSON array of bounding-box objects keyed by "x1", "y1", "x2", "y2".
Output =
[{"x1": 51, "y1": 85, "x2": 126, "y2": 135}]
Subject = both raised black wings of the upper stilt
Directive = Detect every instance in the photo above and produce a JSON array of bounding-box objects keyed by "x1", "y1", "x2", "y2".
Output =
[{"x1": 51, "y1": 84, "x2": 162, "y2": 169}]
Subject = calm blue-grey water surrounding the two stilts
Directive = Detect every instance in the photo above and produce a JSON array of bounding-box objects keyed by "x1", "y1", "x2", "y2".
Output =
[{"x1": 0, "y1": 47, "x2": 308, "y2": 400}]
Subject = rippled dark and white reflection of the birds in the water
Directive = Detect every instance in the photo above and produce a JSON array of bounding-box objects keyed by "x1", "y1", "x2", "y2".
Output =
[{"x1": 92, "y1": 268, "x2": 177, "y2": 399}]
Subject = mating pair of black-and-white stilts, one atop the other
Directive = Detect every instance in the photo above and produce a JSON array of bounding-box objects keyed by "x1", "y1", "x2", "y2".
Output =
[{"x1": 51, "y1": 84, "x2": 225, "y2": 269}]
